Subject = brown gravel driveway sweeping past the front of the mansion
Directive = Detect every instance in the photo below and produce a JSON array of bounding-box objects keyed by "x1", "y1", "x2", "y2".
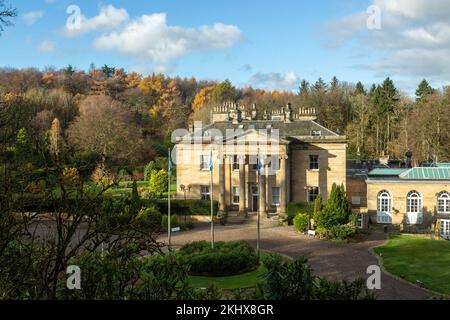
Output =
[{"x1": 165, "y1": 225, "x2": 432, "y2": 300}]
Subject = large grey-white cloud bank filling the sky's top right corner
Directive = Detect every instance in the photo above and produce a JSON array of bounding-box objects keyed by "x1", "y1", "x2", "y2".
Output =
[{"x1": 327, "y1": 0, "x2": 450, "y2": 84}]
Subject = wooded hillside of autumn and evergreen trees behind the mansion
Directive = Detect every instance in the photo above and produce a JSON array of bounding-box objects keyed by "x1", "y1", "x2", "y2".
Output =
[{"x1": 0, "y1": 65, "x2": 450, "y2": 169}]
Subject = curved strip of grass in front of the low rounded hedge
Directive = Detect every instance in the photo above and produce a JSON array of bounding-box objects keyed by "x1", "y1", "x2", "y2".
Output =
[{"x1": 191, "y1": 265, "x2": 266, "y2": 290}]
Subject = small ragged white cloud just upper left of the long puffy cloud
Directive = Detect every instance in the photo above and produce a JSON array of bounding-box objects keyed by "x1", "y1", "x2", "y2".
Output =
[{"x1": 63, "y1": 5, "x2": 129, "y2": 36}]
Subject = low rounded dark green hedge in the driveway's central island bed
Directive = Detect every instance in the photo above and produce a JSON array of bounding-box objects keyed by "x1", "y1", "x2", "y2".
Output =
[{"x1": 179, "y1": 241, "x2": 259, "y2": 277}]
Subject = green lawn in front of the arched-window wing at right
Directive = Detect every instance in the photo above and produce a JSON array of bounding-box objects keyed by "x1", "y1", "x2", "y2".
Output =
[{"x1": 375, "y1": 235, "x2": 450, "y2": 295}]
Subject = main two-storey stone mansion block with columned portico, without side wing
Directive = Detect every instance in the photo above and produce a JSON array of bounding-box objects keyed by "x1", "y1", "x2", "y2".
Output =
[{"x1": 176, "y1": 103, "x2": 347, "y2": 215}]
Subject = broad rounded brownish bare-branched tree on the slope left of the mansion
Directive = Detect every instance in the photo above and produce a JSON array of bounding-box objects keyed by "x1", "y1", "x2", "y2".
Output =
[{"x1": 67, "y1": 96, "x2": 143, "y2": 162}]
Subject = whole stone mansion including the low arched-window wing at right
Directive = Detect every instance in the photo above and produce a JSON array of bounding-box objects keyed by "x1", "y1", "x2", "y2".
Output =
[{"x1": 176, "y1": 103, "x2": 450, "y2": 239}]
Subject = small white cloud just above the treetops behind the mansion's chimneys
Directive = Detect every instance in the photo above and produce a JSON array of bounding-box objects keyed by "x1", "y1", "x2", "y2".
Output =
[{"x1": 249, "y1": 71, "x2": 300, "y2": 90}]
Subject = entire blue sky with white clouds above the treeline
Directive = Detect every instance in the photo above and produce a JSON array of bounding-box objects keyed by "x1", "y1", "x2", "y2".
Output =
[{"x1": 0, "y1": 0, "x2": 450, "y2": 94}]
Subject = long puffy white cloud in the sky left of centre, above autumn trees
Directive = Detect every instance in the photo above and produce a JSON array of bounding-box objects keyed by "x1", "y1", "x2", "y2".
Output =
[{"x1": 94, "y1": 13, "x2": 242, "y2": 68}]
